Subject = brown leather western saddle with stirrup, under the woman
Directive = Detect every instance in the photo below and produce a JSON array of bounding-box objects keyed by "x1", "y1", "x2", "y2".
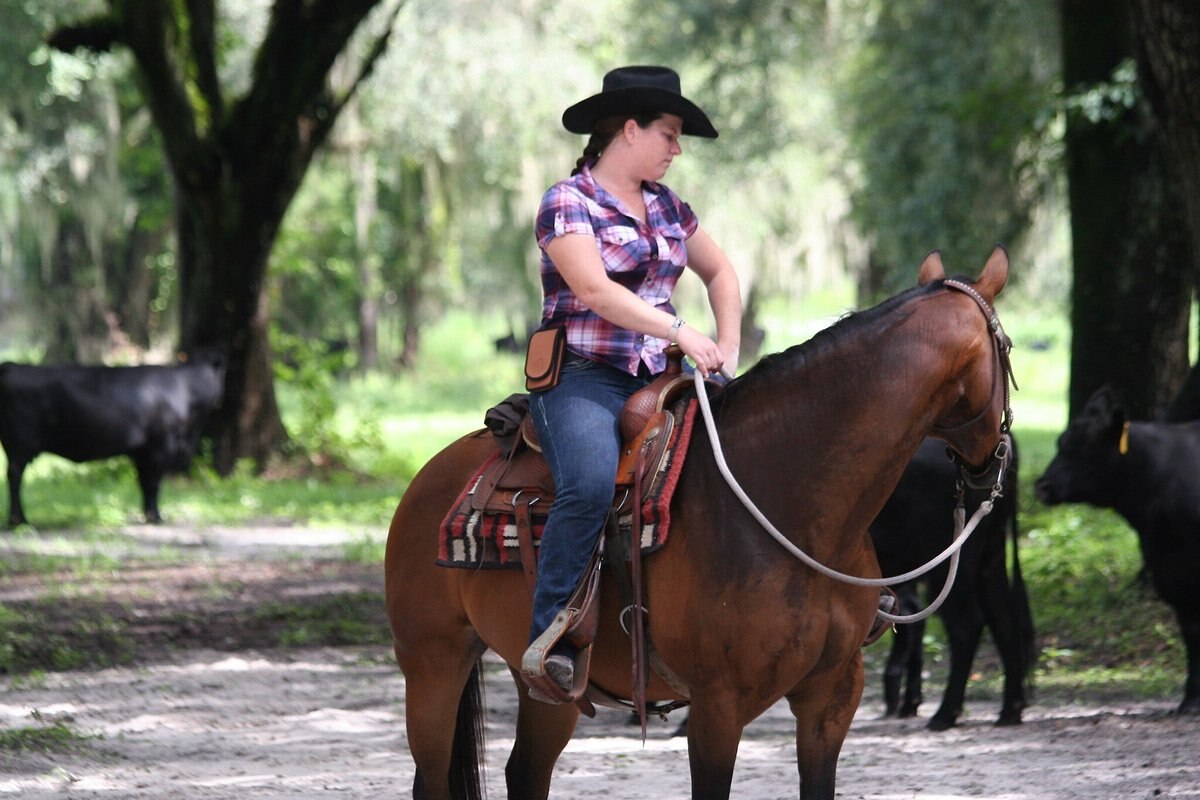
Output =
[{"x1": 470, "y1": 345, "x2": 691, "y2": 728}]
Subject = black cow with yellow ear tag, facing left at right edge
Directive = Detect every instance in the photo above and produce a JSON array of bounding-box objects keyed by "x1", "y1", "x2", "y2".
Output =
[{"x1": 1036, "y1": 387, "x2": 1200, "y2": 714}]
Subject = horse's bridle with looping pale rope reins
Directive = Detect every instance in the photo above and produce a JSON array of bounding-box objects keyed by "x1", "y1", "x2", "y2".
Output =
[{"x1": 694, "y1": 279, "x2": 1016, "y2": 624}]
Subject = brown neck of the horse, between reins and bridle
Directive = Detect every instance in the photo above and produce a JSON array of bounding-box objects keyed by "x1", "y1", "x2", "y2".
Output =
[{"x1": 719, "y1": 299, "x2": 974, "y2": 556}]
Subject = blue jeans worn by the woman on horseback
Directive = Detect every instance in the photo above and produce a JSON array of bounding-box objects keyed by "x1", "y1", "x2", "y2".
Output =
[{"x1": 529, "y1": 355, "x2": 648, "y2": 642}]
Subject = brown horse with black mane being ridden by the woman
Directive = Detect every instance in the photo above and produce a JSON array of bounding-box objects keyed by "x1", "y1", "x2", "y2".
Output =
[{"x1": 385, "y1": 247, "x2": 1008, "y2": 800}]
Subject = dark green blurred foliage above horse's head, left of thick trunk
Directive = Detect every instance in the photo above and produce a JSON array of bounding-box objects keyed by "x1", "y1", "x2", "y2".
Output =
[{"x1": 842, "y1": 0, "x2": 1057, "y2": 294}]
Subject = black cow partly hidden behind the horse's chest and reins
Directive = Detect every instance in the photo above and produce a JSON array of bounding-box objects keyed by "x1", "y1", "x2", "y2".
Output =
[{"x1": 871, "y1": 439, "x2": 1037, "y2": 730}]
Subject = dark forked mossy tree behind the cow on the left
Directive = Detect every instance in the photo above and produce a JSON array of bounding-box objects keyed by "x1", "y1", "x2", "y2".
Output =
[{"x1": 47, "y1": 0, "x2": 396, "y2": 475}]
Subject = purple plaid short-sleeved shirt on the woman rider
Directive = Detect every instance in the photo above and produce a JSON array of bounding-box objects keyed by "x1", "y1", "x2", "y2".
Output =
[{"x1": 536, "y1": 163, "x2": 700, "y2": 375}]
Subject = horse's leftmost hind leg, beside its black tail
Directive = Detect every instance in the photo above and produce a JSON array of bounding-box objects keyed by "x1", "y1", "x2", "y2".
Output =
[{"x1": 396, "y1": 638, "x2": 484, "y2": 800}]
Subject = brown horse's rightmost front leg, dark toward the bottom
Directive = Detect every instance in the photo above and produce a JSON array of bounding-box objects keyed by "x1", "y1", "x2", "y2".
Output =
[{"x1": 787, "y1": 650, "x2": 863, "y2": 800}]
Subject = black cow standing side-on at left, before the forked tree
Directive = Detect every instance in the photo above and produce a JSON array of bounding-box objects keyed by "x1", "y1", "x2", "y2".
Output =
[{"x1": 0, "y1": 356, "x2": 224, "y2": 525}]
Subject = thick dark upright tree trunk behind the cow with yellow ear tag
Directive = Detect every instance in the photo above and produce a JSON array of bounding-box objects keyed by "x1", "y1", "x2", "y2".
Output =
[{"x1": 1062, "y1": 0, "x2": 1194, "y2": 419}]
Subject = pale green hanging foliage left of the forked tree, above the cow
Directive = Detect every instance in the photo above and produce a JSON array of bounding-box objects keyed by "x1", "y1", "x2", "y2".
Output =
[{"x1": 0, "y1": 0, "x2": 173, "y2": 361}]
